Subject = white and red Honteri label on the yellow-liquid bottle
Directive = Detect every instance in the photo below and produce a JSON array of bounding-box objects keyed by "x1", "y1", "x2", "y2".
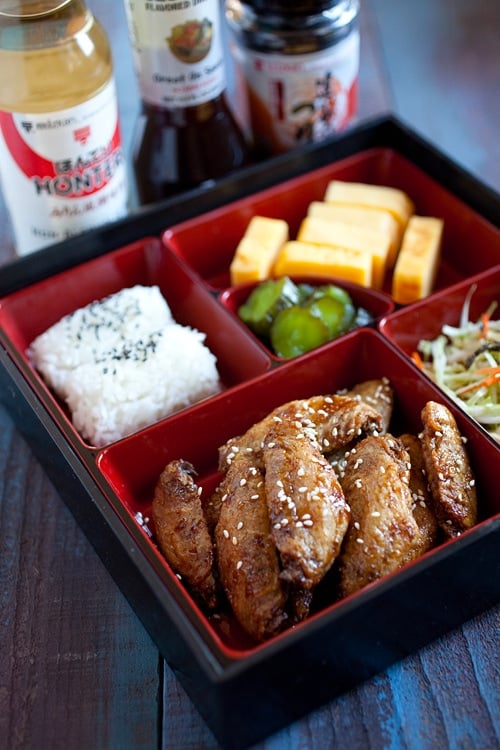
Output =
[{"x1": 0, "y1": 80, "x2": 128, "y2": 255}]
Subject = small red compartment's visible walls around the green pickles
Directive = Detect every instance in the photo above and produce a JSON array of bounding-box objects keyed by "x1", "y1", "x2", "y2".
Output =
[{"x1": 219, "y1": 276, "x2": 395, "y2": 360}]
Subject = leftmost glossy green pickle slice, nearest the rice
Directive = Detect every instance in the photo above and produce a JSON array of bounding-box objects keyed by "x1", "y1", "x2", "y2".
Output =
[{"x1": 238, "y1": 276, "x2": 300, "y2": 336}]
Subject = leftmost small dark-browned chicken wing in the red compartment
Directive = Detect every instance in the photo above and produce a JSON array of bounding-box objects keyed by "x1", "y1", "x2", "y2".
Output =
[{"x1": 151, "y1": 460, "x2": 218, "y2": 609}]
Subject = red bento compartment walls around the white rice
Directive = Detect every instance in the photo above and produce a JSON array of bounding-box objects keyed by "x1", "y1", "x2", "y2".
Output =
[{"x1": 0, "y1": 238, "x2": 270, "y2": 444}]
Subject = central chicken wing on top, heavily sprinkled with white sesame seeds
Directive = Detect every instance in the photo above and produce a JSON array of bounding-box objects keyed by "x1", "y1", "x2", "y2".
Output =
[{"x1": 263, "y1": 420, "x2": 349, "y2": 590}]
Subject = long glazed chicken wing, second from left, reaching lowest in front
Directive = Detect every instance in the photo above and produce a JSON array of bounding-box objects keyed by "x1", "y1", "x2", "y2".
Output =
[{"x1": 215, "y1": 454, "x2": 287, "y2": 641}]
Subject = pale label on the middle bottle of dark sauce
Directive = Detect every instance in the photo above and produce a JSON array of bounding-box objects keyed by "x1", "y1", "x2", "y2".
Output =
[{"x1": 125, "y1": 0, "x2": 226, "y2": 109}]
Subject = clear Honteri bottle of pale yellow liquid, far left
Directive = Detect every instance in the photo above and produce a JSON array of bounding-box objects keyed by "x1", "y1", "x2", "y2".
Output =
[{"x1": 0, "y1": 0, "x2": 128, "y2": 255}]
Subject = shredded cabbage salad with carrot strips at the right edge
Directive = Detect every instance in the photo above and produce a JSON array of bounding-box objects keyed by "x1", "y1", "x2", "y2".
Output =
[{"x1": 413, "y1": 285, "x2": 500, "y2": 442}]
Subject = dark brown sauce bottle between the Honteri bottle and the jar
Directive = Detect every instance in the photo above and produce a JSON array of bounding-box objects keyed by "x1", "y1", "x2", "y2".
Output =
[{"x1": 121, "y1": 0, "x2": 247, "y2": 204}]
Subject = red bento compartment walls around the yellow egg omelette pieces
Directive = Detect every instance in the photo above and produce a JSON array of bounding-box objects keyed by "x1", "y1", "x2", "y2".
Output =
[{"x1": 163, "y1": 148, "x2": 500, "y2": 291}]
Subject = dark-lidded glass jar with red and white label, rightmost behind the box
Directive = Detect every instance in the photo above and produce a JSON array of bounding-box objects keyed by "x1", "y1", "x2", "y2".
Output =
[{"x1": 226, "y1": 0, "x2": 360, "y2": 158}]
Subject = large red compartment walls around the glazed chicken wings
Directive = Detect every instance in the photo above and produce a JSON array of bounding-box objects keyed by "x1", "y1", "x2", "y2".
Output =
[{"x1": 97, "y1": 329, "x2": 500, "y2": 658}]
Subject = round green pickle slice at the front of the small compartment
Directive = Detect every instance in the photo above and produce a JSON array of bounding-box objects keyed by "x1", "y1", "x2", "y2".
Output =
[{"x1": 270, "y1": 305, "x2": 330, "y2": 359}]
